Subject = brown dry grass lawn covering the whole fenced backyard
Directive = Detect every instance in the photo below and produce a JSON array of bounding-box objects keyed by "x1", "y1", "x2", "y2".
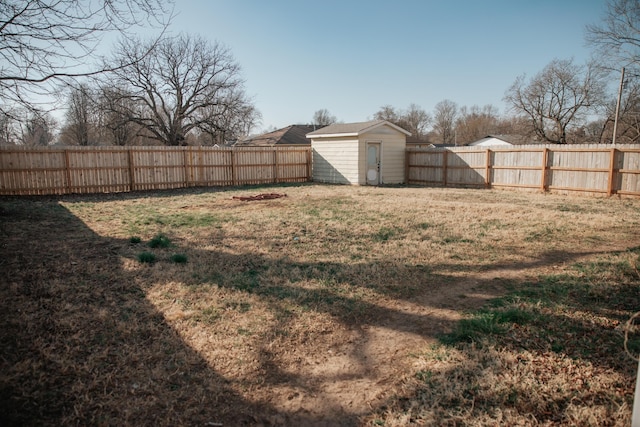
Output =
[{"x1": 0, "y1": 185, "x2": 640, "y2": 426}]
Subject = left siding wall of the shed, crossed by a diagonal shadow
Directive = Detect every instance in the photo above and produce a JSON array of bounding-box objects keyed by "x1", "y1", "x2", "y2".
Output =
[{"x1": 311, "y1": 138, "x2": 359, "y2": 184}]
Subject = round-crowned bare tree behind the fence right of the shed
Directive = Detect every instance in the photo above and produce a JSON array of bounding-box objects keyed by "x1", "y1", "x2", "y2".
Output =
[{"x1": 504, "y1": 59, "x2": 605, "y2": 144}]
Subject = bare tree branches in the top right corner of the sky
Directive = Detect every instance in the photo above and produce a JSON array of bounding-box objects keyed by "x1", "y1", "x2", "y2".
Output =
[{"x1": 586, "y1": 0, "x2": 640, "y2": 71}]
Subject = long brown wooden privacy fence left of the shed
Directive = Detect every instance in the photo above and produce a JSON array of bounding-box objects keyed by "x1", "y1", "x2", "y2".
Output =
[{"x1": 0, "y1": 146, "x2": 311, "y2": 195}]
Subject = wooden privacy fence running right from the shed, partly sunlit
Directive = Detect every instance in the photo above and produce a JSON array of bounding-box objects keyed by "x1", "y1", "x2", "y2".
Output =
[{"x1": 405, "y1": 145, "x2": 640, "y2": 196}]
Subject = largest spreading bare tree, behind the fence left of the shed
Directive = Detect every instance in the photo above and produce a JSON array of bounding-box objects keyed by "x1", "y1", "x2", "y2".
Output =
[{"x1": 104, "y1": 34, "x2": 255, "y2": 145}]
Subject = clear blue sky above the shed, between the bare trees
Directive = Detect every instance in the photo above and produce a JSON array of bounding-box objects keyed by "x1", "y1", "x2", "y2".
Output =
[{"x1": 171, "y1": 0, "x2": 606, "y2": 131}]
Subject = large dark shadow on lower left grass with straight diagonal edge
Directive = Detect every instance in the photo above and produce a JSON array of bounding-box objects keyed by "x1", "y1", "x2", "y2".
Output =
[{"x1": 0, "y1": 201, "x2": 276, "y2": 425}]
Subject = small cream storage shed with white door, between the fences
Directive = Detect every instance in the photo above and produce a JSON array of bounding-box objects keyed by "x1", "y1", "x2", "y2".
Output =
[{"x1": 307, "y1": 120, "x2": 411, "y2": 185}]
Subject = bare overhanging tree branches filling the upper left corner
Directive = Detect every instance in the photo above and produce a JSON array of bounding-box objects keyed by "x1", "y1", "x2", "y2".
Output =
[{"x1": 0, "y1": 0, "x2": 171, "y2": 113}]
